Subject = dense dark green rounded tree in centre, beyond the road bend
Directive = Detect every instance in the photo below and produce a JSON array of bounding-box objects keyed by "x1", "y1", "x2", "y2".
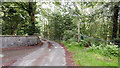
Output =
[{"x1": 45, "y1": 12, "x2": 74, "y2": 40}]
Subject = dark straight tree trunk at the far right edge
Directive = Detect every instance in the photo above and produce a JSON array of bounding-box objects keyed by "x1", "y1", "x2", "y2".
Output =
[{"x1": 112, "y1": 5, "x2": 119, "y2": 39}]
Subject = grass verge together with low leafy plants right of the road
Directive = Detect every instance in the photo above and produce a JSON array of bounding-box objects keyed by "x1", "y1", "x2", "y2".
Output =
[{"x1": 62, "y1": 40, "x2": 118, "y2": 66}]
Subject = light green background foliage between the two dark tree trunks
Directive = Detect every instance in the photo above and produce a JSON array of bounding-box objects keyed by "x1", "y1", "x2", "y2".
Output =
[{"x1": 36, "y1": 2, "x2": 118, "y2": 41}]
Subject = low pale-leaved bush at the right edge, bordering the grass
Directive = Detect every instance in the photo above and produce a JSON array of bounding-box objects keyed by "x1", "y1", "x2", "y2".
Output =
[{"x1": 88, "y1": 44, "x2": 118, "y2": 56}]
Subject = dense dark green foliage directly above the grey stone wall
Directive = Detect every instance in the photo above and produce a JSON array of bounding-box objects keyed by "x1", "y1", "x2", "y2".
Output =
[{"x1": 2, "y1": 2, "x2": 39, "y2": 35}]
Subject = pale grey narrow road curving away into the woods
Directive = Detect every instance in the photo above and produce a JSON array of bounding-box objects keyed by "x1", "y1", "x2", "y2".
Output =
[{"x1": 7, "y1": 40, "x2": 66, "y2": 66}]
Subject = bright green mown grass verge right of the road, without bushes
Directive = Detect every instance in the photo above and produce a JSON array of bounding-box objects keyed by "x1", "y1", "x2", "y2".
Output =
[{"x1": 63, "y1": 42, "x2": 118, "y2": 66}]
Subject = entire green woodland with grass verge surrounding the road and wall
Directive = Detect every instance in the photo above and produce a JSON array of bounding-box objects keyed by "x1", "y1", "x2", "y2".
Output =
[{"x1": 0, "y1": 1, "x2": 120, "y2": 66}]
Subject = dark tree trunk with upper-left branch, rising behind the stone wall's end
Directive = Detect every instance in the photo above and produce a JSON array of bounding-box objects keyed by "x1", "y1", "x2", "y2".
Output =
[{"x1": 17, "y1": 2, "x2": 37, "y2": 35}]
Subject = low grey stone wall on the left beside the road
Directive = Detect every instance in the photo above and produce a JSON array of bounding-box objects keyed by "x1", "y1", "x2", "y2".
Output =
[{"x1": 0, "y1": 36, "x2": 39, "y2": 48}]
